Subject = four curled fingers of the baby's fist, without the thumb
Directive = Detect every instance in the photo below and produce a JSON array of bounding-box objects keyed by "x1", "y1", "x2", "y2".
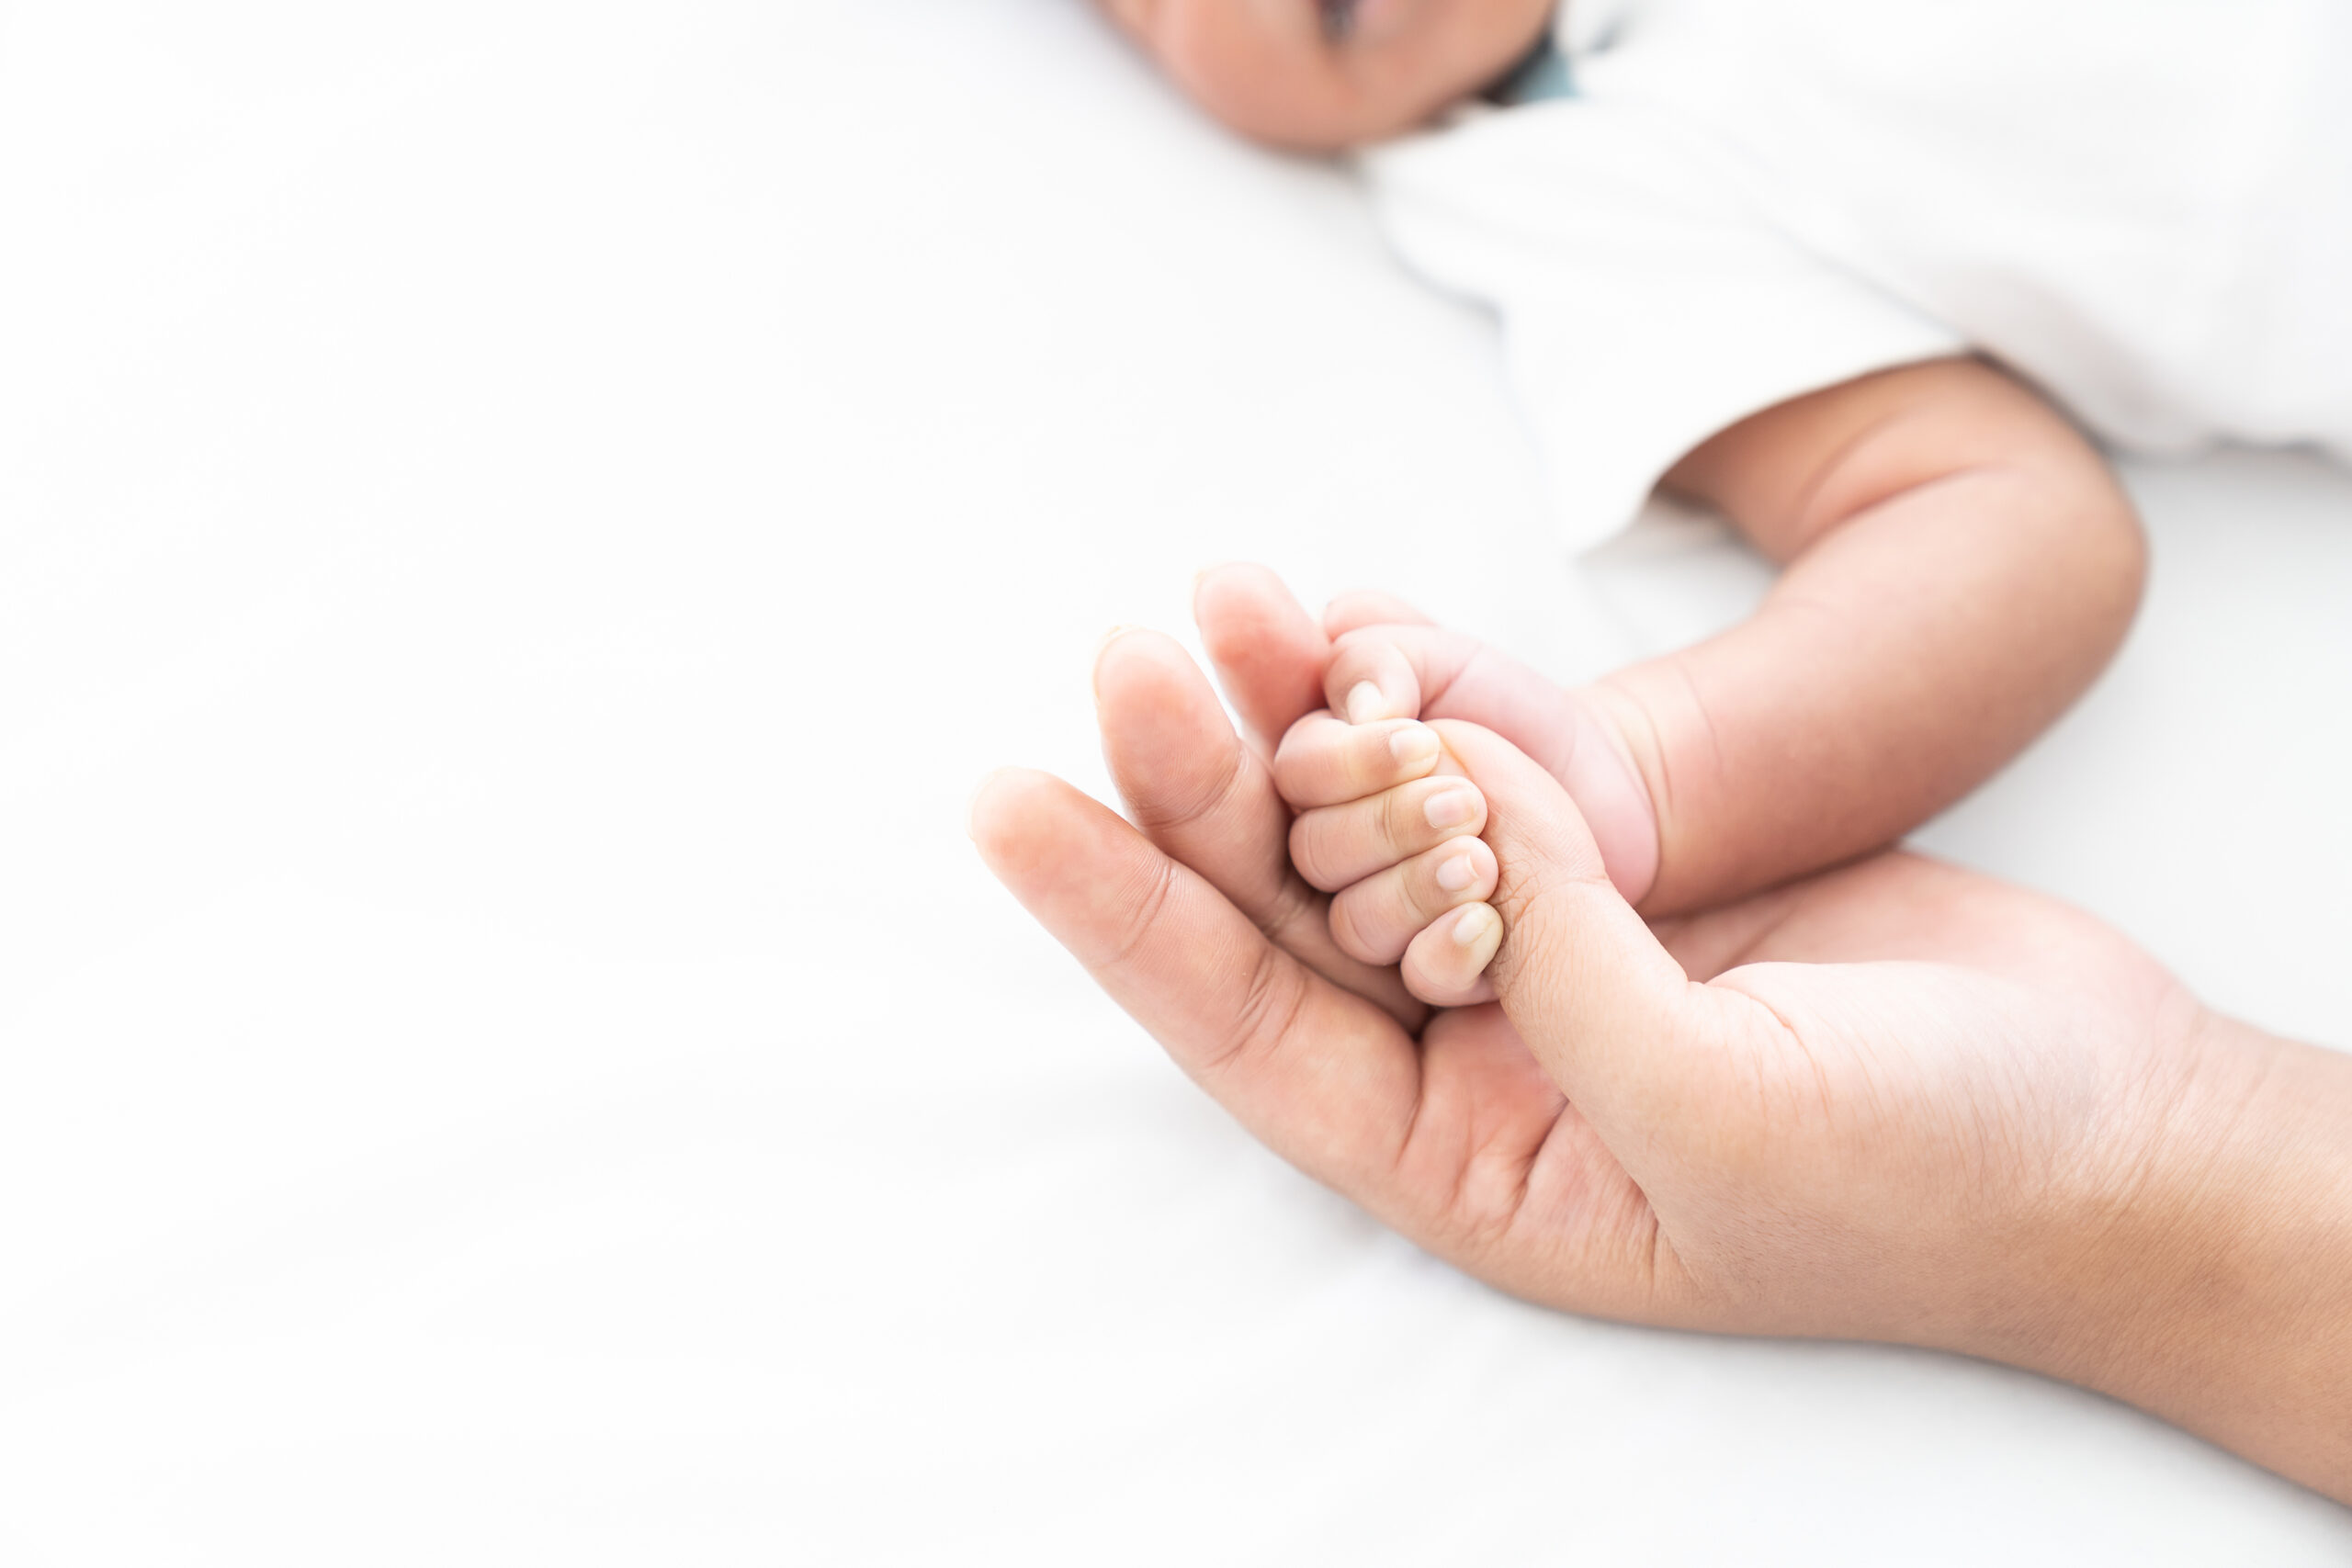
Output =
[{"x1": 1275, "y1": 712, "x2": 1503, "y2": 1006}]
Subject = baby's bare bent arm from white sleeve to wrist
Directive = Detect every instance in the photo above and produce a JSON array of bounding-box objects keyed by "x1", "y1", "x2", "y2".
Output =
[{"x1": 1585, "y1": 365, "x2": 2143, "y2": 912}]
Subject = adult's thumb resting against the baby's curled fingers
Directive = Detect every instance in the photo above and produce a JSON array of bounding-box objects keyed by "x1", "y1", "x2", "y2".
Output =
[{"x1": 1435, "y1": 719, "x2": 1705, "y2": 1142}]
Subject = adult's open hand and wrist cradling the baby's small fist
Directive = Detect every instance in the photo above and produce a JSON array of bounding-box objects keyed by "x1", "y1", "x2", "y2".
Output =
[{"x1": 974, "y1": 573, "x2": 2352, "y2": 1497}]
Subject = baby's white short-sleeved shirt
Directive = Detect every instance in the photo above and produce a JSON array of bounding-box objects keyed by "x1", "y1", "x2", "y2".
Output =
[{"x1": 1360, "y1": 0, "x2": 2352, "y2": 547}]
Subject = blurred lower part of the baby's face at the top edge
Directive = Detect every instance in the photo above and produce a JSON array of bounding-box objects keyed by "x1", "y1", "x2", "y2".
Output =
[{"x1": 1101, "y1": 0, "x2": 1555, "y2": 151}]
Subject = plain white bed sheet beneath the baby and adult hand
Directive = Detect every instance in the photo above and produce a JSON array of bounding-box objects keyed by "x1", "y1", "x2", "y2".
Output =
[{"x1": 0, "y1": 0, "x2": 2352, "y2": 1568}]
